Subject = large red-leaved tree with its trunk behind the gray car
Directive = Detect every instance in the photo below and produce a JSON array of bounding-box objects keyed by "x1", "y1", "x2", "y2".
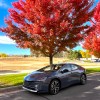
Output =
[{"x1": 1, "y1": 0, "x2": 94, "y2": 67}]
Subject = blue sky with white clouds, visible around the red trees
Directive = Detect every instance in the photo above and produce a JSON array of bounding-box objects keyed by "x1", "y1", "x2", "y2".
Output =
[{"x1": 0, "y1": 0, "x2": 99, "y2": 55}]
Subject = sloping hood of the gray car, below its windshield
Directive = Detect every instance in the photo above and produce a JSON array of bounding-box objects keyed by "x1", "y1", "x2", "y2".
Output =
[{"x1": 25, "y1": 71, "x2": 54, "y2": 81}]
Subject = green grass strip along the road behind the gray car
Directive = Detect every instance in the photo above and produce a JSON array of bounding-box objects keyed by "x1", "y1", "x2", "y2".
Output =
[{"x1": 0, "y1": 68, "x2": 100, "y2": 88}]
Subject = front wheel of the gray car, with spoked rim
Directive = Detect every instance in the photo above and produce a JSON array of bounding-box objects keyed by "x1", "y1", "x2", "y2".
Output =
[{"x1": 49, "y1": 80, "x2": 60, "y2": 95}]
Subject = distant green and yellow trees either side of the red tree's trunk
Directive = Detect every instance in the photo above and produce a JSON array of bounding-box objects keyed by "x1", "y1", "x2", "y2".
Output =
[{"x1": 31, "y1": 50, "x2": 91, "y2": 60}]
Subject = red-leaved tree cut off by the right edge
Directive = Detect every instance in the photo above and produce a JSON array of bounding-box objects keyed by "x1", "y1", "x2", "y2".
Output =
[{"x1": 83, "y1": 2, "x2": 100, "y2": 58}]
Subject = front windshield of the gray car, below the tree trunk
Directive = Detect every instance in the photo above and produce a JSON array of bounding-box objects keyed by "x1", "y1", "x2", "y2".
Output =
[{"x1": 38, "y1": 64, "x2": 63, "y2": 71}]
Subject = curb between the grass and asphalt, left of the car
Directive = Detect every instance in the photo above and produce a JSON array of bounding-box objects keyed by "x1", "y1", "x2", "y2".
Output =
[{"x1": 0, "y1": 85, "x2": 22, "y2": 93}]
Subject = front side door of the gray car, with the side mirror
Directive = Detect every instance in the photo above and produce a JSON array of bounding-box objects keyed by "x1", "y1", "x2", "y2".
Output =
[{"x1": 59, "y1": 64, "x2": 71, "y2": 87}]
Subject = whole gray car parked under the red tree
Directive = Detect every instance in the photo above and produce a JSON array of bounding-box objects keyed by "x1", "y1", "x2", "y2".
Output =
[{"x1": 23, "y1": 63, "x2": 87, "y2": 94}]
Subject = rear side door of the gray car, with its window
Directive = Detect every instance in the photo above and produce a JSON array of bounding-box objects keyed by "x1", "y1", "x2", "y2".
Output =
[{"x1": 71, "y1": 64, "x2": 80, "y2": 83}]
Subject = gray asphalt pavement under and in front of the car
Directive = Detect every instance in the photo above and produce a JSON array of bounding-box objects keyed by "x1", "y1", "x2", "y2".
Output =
[{"x1": 0, "y1": 73, "x2": 100, "y2": 100}]
